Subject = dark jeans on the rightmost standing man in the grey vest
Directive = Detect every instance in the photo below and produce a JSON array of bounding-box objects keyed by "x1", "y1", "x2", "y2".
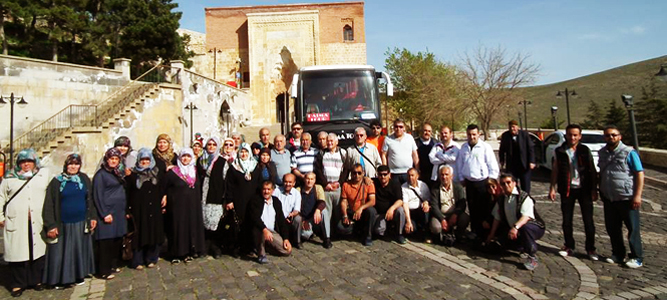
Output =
[{"x1": 603, "y1": 199, "x2": 644, "y2": 260}]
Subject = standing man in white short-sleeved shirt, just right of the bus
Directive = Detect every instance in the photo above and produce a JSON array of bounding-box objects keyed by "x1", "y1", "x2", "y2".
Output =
[{"x1": 382, "y1": 119, "x2": 419, "y2": 184}]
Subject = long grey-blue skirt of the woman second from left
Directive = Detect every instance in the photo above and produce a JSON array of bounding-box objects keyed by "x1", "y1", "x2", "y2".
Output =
[{"x1": 43, "y1": 221, "x2": 95, "y2": 285}]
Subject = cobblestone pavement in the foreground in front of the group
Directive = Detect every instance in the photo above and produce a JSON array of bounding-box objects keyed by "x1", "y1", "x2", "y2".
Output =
[{"x1": 0, "y1": 170, "x2": 667, "y2": 299}]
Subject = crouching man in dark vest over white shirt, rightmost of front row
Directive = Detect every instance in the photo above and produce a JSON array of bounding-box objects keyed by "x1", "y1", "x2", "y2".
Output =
[{"x1": 486, "y1": 174, "x2": 545, "y2": 270}]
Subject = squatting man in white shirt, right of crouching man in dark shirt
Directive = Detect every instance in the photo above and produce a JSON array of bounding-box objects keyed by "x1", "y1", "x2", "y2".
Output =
[{"x1": 401, "y1": 168, "x2": 431, "y2": 242}]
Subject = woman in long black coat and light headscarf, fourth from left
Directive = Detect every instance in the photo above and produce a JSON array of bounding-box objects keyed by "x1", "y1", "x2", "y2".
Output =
[{"x1": 126, "y1": 148, "x2": 167, "y2": 270}]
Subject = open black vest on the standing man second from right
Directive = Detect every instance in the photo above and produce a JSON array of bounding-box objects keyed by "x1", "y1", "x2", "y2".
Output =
[{"x1": 556, "y1": 143, "x2": 597, "y2": 197}]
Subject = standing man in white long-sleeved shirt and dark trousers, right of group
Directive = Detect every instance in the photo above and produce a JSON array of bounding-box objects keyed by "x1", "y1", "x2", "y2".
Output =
[{"x1": 455, "y1": 124, "x2": 500, "y2": 238}]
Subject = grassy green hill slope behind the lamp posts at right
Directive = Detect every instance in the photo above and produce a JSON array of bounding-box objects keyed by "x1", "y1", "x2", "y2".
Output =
[{"x1": 516, "y1": 55, "x2": 667, "y2": 128}]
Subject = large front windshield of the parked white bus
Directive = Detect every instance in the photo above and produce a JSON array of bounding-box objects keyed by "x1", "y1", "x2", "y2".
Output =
[{"x1": 301, "y1": 70, "x2": 379, "y2": 122}]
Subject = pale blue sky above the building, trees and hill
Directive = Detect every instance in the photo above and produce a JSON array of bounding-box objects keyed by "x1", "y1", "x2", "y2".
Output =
[{"x1": 174, "y1": 0, "x2": 667, "y2": 84}]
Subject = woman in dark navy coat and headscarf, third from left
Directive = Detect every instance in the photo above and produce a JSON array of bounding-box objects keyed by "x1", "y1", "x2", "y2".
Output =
[{"x1": 93, "y1": 148, "x2": 127, "y2": 280}]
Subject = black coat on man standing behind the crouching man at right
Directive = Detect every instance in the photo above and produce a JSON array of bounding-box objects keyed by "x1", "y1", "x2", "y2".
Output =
[{"x1": 498, "y1": 130, "x2": 535, "y2": 171}]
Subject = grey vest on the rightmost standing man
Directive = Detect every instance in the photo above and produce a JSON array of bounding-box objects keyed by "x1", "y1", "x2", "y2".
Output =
[{"x1": 599, "y1": 142, "x2": 634, "y2": 201}]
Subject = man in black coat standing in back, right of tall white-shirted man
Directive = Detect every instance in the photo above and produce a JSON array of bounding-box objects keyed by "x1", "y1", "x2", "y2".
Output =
[{"x1": 498, "y1": 120, "x2": 535, "y2": 194}]
